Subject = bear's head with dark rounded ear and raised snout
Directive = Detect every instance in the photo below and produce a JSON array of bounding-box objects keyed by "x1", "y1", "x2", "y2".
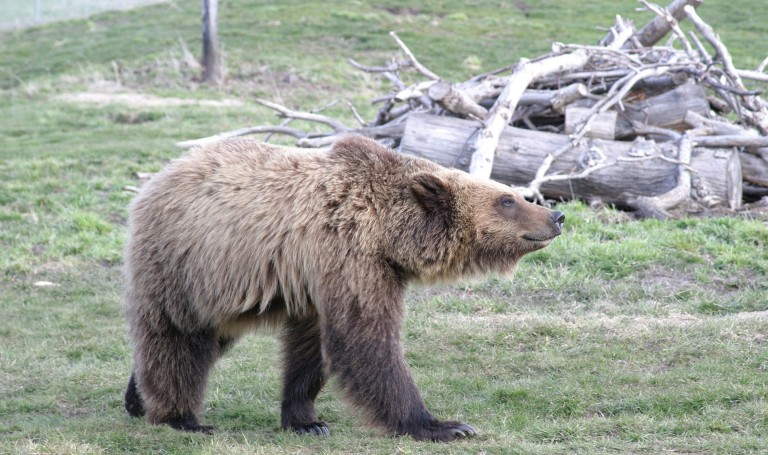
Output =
[{"x1": 396, "y1": 168, "x2": 565, "y2": 282}]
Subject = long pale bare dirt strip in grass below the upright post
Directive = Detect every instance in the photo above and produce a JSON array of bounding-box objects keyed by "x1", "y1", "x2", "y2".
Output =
[{"x1": 54, "y1": 92, "x2": 244, "y2": 108}]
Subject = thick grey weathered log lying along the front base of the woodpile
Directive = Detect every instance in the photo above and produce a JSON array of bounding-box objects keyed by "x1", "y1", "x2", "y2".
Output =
[{"x1": 400, "y1": 114, "x2": 741, "y2": 208}]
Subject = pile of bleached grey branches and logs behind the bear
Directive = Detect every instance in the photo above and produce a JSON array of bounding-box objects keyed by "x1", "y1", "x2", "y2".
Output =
[{"x1": 177, "y1": 0, "x2": 768, "y2": 218}]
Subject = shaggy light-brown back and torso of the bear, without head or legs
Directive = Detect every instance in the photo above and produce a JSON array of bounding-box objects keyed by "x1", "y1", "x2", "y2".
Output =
[{"x1": 126, "y1": 139, "x2": 420, "y2": 325}]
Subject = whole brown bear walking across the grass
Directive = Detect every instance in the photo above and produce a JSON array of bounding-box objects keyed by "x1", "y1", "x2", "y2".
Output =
[{"x1": 125, "y1": 136, "x2": 564, "y2": 441}]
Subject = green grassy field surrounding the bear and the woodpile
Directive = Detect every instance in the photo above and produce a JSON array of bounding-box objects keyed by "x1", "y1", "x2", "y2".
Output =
[{"x1": 0, "y1": 0, "x2": 768, "y2": 454}]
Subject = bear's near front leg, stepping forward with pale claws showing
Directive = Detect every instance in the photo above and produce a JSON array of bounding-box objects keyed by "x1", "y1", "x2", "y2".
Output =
[{"x1": 322, "y1": 283, "x2": 476, "y2": 441}]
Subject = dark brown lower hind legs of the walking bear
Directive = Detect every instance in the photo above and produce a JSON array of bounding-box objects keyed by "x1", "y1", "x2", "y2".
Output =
[{"x1": 126, "y1": 323, "x2": 225, "y2": 433}]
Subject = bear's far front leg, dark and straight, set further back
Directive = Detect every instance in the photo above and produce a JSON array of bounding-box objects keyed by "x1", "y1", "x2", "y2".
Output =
[{"x1": 281, "y1": 315, "x2": 330, "y2": 436}]
